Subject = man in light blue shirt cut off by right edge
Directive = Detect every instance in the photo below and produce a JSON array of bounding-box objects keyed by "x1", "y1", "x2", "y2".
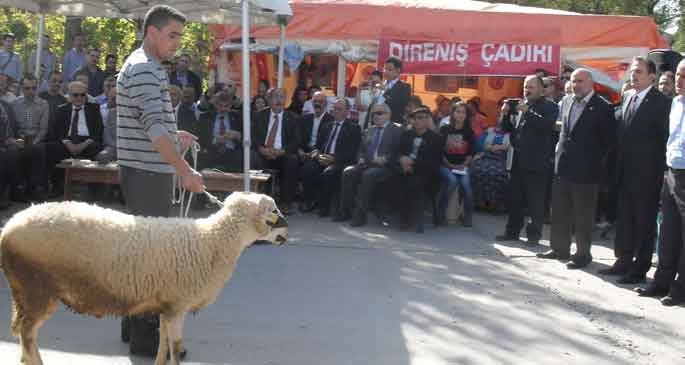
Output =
[{"x1": 636, "y1": 60, "x2": 685, "y2": 306}]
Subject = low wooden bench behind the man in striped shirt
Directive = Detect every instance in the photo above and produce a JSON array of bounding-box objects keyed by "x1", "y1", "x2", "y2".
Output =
[{"x1": 57, "y1": 160, "x2": 274, "y2": 200}]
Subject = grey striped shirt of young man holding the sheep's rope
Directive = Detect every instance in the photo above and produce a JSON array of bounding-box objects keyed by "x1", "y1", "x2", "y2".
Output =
[{"x1": 117, "y1": 48, "x2": 178, "y2": 174}]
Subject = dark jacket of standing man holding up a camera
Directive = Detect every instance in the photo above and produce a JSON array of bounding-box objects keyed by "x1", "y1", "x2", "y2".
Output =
[{"x1": 511, "y1": 97, "x2": 559, "y2": 172}]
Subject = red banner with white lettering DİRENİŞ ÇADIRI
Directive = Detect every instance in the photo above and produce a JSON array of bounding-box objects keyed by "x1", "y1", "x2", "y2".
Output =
[{"x1": 378, "y1": 39, "x2": 561, "y2": 76}]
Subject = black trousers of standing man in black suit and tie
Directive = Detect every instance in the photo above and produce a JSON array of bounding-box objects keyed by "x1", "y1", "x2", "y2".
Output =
[{"x1": 614, "y1": 177, "x2": 661, "y2": 276}]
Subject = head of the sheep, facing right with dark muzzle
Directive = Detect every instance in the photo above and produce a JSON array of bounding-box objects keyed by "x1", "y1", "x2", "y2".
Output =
[{"x1": 224, "y1": 192, "x2": 288, "y2": 245}]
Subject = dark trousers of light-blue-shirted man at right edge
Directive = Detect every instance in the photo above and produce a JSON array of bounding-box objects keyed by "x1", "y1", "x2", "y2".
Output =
[{"x1": 654, "y1": 170, "x2": 685, "y2": 298}]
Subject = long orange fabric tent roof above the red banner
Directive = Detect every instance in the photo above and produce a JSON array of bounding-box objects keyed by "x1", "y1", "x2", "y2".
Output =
[{"x1": 210, "y1": 0, "x2": 668, "y2": 48}]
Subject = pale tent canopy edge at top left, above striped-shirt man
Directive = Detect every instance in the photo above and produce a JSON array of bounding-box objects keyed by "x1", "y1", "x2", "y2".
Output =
[{"x1": 2, "y1": 0, "x2": 293, "y2": 25}]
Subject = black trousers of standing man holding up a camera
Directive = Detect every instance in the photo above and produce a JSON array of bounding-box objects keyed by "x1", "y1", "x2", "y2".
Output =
[{"x1": 506, "y1": 166, "x2": 547, "y2": 241}]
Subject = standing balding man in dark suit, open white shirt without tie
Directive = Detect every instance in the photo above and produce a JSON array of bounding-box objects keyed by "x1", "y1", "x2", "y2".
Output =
[{"x1": 537, "y1": 68, "x2": 616, "y2": 269}]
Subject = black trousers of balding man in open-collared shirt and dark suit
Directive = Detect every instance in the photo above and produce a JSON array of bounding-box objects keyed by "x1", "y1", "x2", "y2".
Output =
[{"x1": 550, "y1": 177, "x2": 599, "y2": 257}]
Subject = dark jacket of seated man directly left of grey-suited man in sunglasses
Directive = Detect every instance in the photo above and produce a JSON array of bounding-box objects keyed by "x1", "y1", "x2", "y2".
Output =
[{"x1": 316, "y1": 120, "x2": 362, "y2": 166}]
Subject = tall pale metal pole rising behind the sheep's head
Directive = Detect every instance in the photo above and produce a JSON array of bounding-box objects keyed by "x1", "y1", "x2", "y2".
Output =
[{"x1": 242, "y1": 0, "x2": 251, "y2": 191}]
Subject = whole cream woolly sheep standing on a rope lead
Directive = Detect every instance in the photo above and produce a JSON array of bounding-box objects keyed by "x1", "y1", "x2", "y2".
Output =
[{"x1": 0, "y1": 192, "x2": 288, "y2": 365}]
